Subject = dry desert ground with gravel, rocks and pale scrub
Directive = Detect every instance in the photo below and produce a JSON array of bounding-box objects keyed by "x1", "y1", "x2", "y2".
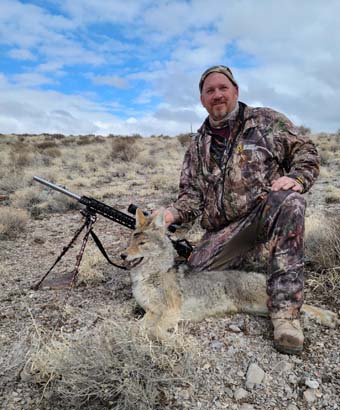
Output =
[{"x1": 0, "y1": 130, "x2": 340, "y2": 410}]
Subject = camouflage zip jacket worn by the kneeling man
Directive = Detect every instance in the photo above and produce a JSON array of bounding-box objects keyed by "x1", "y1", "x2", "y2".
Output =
[{"x1": 172, "y1": 103, "x2": 319, "y2": 231}]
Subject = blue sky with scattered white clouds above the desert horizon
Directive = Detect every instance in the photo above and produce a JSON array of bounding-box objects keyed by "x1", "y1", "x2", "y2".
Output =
[{"x1": 0, "y1": 0, "x2": 340, "y2": 136}]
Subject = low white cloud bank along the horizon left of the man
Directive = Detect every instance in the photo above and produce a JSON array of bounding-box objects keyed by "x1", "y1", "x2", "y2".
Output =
[{"x1": 0, "y1": 80, "x2": 202, "y2": 136}]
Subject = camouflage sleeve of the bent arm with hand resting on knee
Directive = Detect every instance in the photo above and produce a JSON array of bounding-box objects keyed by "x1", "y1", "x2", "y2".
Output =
[{"x1": 272, "y1": 114, "x2": 320, "y2": 193}]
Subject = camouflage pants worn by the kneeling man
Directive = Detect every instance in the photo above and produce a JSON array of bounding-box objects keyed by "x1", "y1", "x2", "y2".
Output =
[{"x1": 189, "y1": 190, "x2": 306, "y2": 312}]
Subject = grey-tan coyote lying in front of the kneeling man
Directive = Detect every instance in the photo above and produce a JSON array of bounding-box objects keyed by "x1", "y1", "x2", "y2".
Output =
[{"x1": 122, "y1": 209, "x2": 338, "y2": 340}]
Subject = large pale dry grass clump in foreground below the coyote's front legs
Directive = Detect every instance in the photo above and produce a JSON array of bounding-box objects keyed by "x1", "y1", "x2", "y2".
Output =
[{"x1": 25, "y1": 318, "x2": 195, "y2": 410}]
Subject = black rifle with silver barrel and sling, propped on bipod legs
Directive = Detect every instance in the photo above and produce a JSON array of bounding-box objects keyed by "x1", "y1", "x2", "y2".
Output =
[{"x1": 32, "y1": 176, "x2": 193, "y2": 290}]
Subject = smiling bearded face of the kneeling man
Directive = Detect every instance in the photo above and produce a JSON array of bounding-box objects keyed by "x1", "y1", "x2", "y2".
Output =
[{"x1": 201, "y1": 73, "x2": 238, "y2": 121}]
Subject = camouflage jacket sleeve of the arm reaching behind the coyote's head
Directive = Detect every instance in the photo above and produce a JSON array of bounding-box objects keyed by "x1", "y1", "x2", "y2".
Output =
[{"x1": 170, "y1": 137, "x2": 203, "y2": 223}]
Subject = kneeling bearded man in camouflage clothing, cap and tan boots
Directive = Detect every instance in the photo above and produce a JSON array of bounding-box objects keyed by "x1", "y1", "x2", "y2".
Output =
[{"x1": 166, "y1": 66, "x2": 319, "y2": 354}]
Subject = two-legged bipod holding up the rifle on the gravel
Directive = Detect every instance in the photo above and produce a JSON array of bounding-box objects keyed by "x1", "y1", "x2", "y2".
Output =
[{"x1": 32, "y1": 209, "x2": 97, "y2": 290}]
